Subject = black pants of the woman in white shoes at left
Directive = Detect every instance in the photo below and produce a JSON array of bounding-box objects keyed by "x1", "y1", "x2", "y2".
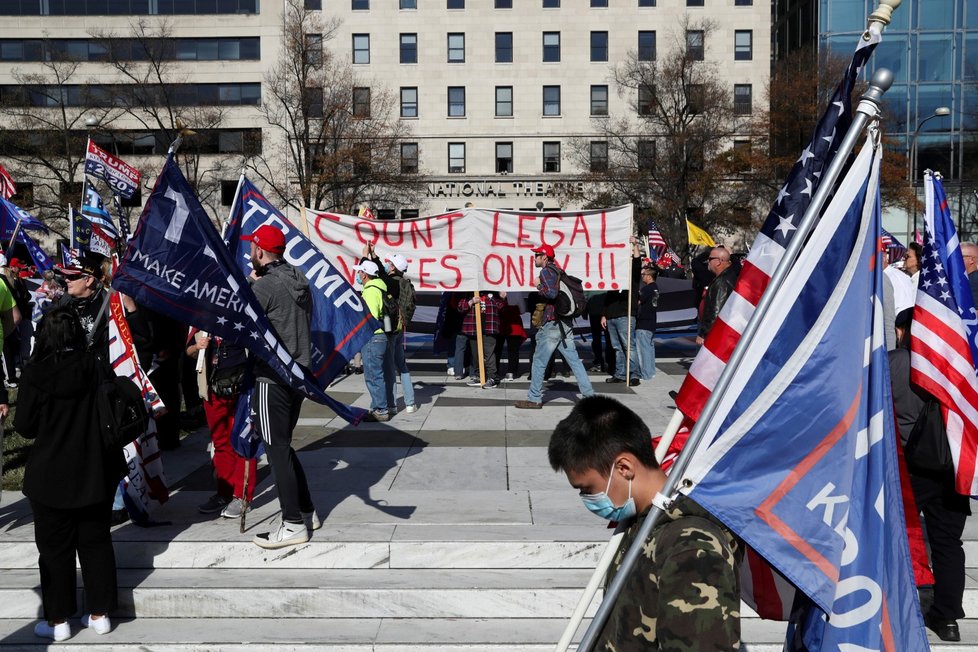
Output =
[{"x1": 31, "y1": 499, "x2": 117, "y2": 621}]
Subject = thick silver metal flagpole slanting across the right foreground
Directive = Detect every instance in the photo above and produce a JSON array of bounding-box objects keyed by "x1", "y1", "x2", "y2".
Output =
[{"x1": 577, "y1": 65, "x2": 893, "y2": 652}]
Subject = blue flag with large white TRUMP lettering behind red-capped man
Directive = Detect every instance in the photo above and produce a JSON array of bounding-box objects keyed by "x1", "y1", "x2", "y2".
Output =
[{"x1": 224, "y1": 176, "x2": 381, "y2": 388}]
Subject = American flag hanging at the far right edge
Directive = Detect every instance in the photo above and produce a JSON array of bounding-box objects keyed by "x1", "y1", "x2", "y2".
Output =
[{"x1": 910, "y1": 172, "x2": 978, "y2": 496}]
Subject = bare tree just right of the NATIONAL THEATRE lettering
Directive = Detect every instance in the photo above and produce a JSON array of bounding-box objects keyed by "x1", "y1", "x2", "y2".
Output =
[{"x1": 572, "y1": 17, "x2": 757, "y2": 250}]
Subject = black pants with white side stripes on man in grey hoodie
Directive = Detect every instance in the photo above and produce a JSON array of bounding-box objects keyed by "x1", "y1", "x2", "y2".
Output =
[{"x1": 251, "y1": 380, "x2": 313, "y2": 523}]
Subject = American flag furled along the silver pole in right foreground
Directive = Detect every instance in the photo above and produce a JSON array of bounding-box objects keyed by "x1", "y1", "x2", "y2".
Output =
[{"x1": 670, "y1": 34, "x2": 881, "y2": 620}]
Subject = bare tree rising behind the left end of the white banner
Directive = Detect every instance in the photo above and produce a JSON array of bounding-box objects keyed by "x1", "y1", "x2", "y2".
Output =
[{"x1": 255, "y1": 0, "x2": 422, "y2": 212}]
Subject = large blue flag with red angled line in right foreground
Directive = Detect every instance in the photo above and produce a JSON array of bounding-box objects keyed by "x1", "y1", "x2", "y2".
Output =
[{"x1": 679, "y1": 134, "x2": 928, "y2": 652}]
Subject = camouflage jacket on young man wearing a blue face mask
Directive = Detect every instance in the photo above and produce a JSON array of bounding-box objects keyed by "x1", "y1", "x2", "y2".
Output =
[{"x1": 595, "y1": 497, "x2": 743, "y2": 652}]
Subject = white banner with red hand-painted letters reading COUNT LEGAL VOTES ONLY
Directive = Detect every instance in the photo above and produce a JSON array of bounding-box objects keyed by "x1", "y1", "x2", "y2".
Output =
[{"x1": 305, "y1": 205, "x2": 632, "y2": 292}]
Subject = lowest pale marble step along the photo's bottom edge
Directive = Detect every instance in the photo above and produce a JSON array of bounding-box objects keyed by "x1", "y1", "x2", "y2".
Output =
[{"x1": 0, "y1": 618, "x2": 978, "y2": 652}]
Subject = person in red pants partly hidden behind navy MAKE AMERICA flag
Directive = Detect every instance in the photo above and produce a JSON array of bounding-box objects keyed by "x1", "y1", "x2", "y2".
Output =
[{"x1": 186, "y1": 329, "x2": 258, "y2": 518}]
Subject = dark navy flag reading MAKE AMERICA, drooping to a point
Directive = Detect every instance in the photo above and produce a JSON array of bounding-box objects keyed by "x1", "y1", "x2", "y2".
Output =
[{"x1": 112, "y1": 156, "x2": 366, "y2": 423}]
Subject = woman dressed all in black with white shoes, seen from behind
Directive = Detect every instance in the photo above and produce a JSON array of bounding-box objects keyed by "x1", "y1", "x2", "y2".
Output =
[{"x1": 14, "y1": 308, "x2": 125, "y2": 641}]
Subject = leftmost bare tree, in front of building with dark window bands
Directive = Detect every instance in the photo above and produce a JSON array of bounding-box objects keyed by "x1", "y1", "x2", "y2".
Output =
[{"x1": 0, "y1": 56, "x2": 118, "y2": 232}]
